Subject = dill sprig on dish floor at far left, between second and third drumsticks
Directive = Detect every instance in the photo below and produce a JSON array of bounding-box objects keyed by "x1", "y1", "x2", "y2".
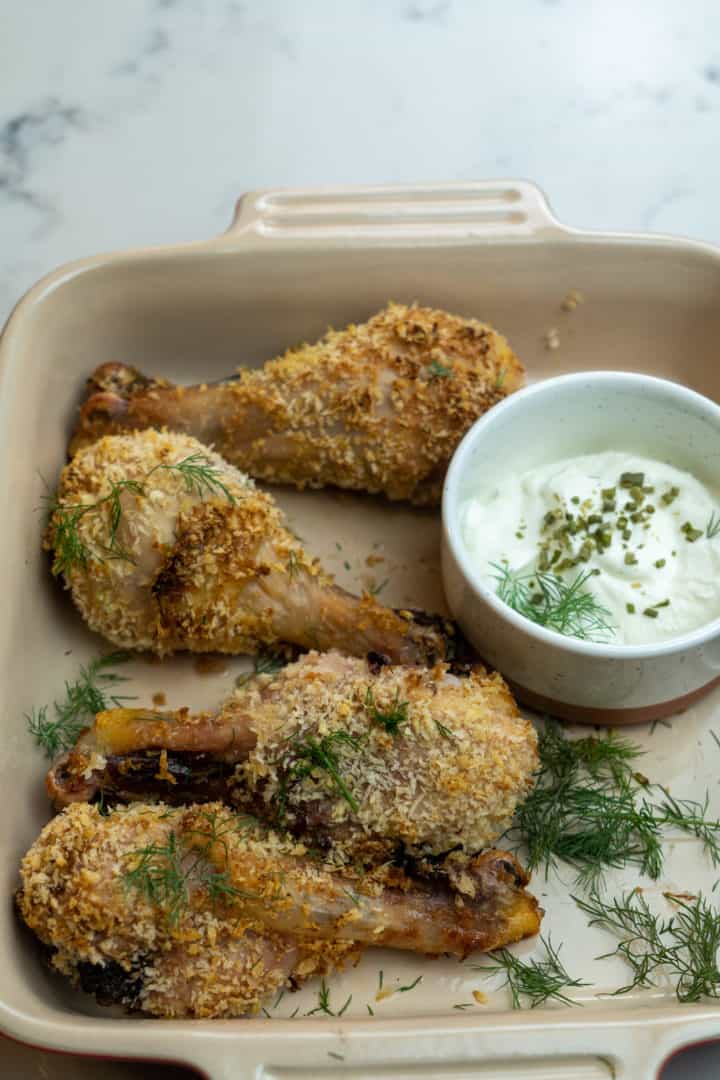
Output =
[{"x1": 25, "y1": 651, "x2": 132, "y2": 757}]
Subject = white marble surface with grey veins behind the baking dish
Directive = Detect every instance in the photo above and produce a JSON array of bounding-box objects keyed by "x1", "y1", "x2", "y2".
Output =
[{"x1": 0, "y1": 0, "x2": 720, "y2": 1080}]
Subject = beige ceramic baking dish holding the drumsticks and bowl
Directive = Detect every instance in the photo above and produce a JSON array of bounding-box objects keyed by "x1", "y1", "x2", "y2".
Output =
[{"x1": 0, "y1": 183, "x2": 720, "y2": 1080}]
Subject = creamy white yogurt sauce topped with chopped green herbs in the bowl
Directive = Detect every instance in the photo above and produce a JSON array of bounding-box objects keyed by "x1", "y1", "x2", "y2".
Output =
[{"x1": 460, "y1": 451, "x2": 720, "y2": 645}]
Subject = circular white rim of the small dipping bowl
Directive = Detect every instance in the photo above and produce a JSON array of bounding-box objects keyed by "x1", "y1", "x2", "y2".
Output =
[{"x1": 441, "y1": 369, "x2": 720, "y2": 661}]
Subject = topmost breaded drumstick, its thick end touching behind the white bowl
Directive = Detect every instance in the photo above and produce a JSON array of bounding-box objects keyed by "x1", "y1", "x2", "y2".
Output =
[{"x1": 70, "y1": 303, "x2": 525, "y2": 505}]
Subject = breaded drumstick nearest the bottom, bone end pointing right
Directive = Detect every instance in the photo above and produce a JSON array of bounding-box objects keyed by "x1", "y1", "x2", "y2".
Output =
[{"x1": 16, "y1": 804, "x2": 540, "y2": 1016}]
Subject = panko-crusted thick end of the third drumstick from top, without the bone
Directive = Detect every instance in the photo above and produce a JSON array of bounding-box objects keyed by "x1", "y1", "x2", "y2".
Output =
[{"x1": 237, "y1": 653, "x2": 538, "y2": 863}]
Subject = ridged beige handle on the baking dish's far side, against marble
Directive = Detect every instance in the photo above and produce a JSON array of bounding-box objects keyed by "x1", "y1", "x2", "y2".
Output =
[{"x1": 223, "y1": 180, "x2": 570, "y2": 243}]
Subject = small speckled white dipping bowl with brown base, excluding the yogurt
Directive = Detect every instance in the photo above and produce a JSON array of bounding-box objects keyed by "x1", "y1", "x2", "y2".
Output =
[{"x1": 443, "y1": 372, "x2": 720, "y2": 725}]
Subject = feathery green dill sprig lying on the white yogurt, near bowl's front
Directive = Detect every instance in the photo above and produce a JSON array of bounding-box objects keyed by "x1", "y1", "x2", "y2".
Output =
[{"x1": 490, "y1": 563, "x2": 614, "y2": 644}]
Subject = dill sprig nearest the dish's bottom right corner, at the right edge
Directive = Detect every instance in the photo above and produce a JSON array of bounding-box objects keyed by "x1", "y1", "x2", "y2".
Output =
[{"x1": 573, "y1": 889, "x2": 720, "y2": 1002}]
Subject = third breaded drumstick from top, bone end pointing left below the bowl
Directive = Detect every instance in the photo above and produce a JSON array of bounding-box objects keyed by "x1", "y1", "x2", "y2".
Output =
[{"x1": 47, "y1": 652, "x2": 538, "y2": 865}]
